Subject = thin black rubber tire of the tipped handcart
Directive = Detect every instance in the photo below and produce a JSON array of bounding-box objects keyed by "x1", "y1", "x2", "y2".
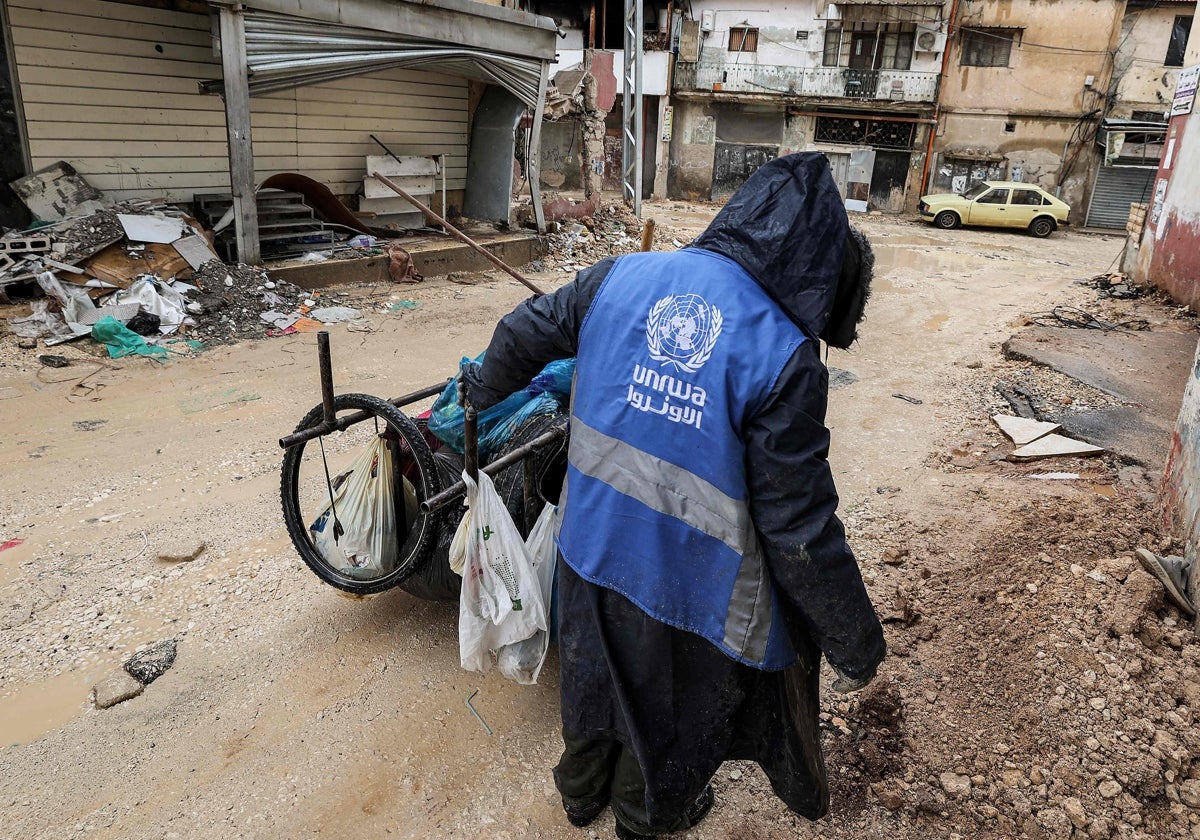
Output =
[{"x1": 280, "y1": 394, "x2": 443, "y2": 595}]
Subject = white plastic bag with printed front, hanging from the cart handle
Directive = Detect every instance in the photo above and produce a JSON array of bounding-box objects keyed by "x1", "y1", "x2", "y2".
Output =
[{"x1": 458, "y1": 472, "x2": 546, "y2": 673}]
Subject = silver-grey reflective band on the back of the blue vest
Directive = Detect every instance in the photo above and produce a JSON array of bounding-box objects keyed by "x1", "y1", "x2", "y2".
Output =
[{"x1": 568, "y1": 416, "x2": 772, "y2": 661}]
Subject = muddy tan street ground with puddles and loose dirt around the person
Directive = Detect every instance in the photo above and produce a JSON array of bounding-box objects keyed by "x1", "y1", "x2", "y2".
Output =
[{"x1": 0, "y1": 204, "x2": 1200, "y2": 840}]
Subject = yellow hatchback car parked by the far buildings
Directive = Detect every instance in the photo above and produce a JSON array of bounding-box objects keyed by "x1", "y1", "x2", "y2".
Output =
[{"x1": 918, "y1": 181, "x2": 1070, "y2": 236}]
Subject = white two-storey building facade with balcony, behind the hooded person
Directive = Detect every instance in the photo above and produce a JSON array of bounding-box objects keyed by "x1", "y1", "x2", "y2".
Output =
[{"x1": 667, "y1": 0, "x2": 947, "y2": 211}]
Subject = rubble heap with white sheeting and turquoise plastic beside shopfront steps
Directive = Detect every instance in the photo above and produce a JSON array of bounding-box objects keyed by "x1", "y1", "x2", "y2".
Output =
[{"x1": 0, "y1": 202, "x2": 359, "y2": 355}]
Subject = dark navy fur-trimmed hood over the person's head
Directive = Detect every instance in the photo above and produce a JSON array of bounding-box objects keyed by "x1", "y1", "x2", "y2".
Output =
[{"x1": 691, "y1": 152, "x2": 875, "y2": 348}]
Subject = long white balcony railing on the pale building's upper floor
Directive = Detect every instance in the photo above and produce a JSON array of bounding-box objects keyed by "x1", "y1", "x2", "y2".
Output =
[{"x1": 674, "y1": 61, "x2": 937, "y2": 102}]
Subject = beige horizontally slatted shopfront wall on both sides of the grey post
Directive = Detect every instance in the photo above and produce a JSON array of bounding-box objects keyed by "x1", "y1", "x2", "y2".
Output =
[{"x1": 7, "y1": 0, "x2": 468, "y2": 210}]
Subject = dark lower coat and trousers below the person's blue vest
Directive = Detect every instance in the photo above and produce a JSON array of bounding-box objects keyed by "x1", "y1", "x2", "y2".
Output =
[{"x1": 554, "y1": 557, "x2": 829, "y2": 834}]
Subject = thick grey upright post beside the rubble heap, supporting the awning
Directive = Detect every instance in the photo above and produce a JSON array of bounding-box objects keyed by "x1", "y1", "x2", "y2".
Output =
[{"x1": 220, "y1": 6, "x2": 262, "y2": 265}]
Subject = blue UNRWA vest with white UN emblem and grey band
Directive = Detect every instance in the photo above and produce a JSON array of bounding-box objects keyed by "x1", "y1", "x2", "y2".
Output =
[{"x1": 559, "y1": 248, "x2": 805, "y2": 670}]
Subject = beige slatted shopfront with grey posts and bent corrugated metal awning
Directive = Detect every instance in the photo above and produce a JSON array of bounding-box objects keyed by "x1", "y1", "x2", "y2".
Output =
[{"x1": 0, "y1": 0, "x2": 556, "y2": 262}]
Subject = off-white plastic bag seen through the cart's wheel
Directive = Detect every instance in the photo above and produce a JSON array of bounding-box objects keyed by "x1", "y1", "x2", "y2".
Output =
[{"x1": 308, "y1": 437, "x2": 407, "y2": 578}]
